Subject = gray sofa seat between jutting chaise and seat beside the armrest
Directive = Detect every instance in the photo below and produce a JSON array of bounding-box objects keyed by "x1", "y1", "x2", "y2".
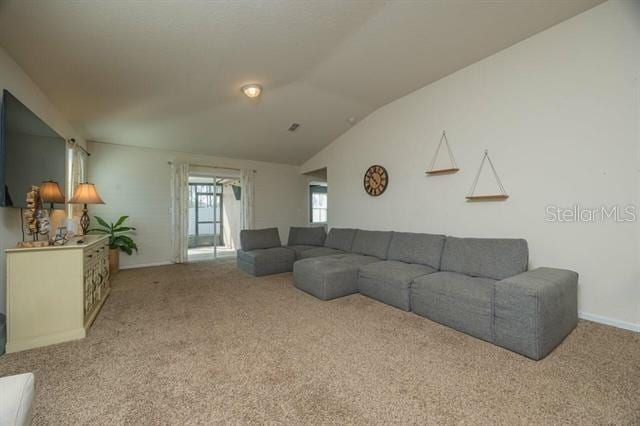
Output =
[{"x1": 358, "y1": 260, "x2": 435, "y2": 311}]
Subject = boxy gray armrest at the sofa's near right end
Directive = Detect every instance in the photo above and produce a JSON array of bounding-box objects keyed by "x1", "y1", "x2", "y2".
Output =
[{"x1": 494, "y1": 268, "x2": 578, "y2": 360}]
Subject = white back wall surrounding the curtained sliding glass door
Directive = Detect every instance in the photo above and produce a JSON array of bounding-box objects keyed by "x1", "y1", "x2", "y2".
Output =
[{"x1": 89, "y1": 142, "x2": 306, "y2": 267}]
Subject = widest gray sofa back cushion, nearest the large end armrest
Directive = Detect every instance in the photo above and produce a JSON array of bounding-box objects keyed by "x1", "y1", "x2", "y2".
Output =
[{"x1": 440, "y1": 237, "x2": 529, "y2": 280}]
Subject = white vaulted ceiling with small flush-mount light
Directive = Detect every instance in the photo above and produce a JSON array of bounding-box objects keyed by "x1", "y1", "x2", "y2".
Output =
[{"x1": 0, "y1": 0, "x2": 601, "y2": 164}]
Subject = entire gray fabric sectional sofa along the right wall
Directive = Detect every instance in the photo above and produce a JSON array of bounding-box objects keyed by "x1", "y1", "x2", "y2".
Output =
[{"x1": 238, "y1": 228, "x2": 578, "y2": 360}]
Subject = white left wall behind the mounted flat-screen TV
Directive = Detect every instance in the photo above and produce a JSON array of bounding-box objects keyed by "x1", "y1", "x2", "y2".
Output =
[{"x1": 0, "y1": 47, "x2": 85, "y2": 313}]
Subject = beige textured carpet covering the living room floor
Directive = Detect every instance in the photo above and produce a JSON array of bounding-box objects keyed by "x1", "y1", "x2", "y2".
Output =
[{"x1": 0, "y1": 261, "x2": 640, "y2": 424}]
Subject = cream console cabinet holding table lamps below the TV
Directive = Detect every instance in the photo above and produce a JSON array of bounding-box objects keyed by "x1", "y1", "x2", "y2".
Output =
[{"x1": 6, "y1": 235, "x2": 110, "y2": 352}]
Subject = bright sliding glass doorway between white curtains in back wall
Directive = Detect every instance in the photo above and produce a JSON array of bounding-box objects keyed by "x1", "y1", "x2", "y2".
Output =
[{"x1": 187, "y1": 175, "x2": 241, "y2": 262}]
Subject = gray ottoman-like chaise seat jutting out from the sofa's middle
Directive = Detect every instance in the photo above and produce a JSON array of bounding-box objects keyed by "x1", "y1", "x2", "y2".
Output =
[{"x1": 293, "y1": 255, "x2": 379, "y2": 300}]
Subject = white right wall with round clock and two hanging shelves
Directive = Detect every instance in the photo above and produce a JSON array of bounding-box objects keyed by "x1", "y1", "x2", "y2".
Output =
[{"x1": 301, "y1": 1, "x2": 640, "y2": 329}]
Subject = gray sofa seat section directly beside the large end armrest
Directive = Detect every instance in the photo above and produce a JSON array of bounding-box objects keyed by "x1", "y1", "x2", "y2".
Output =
[{"x1": 411, "y1": 272, "x2": 496, "y2": 342}]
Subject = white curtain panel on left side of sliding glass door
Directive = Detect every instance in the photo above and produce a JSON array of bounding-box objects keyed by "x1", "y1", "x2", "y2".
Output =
[{"x1": 171, "y1": 164, "x2": 189, "y2": 263}]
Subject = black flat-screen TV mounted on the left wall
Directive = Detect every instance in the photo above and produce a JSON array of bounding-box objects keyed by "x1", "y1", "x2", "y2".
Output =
[{"x1": 0, "y1": 90, "x2": 67, "y2": 207}]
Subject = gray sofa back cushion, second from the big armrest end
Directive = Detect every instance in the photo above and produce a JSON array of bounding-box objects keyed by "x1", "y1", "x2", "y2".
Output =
[{"x1": 387, "y1": 232, "x2": 445, "y2": 269}]
